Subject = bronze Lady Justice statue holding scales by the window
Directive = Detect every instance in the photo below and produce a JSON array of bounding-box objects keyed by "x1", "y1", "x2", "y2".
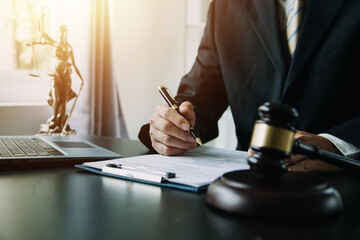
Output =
[{"x1": 27, "y1": 9, "x2": 84, "y2": 135}]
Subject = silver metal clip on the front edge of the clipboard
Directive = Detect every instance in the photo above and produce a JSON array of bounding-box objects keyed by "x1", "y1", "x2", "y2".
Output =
[{"x1": 102, "y1": 164, "x2": 176, "y2": 183}]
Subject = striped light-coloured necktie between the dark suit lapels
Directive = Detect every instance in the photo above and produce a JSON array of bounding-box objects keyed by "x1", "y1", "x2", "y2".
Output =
[{"x1": 286, "y1": 0, "x2": 304, "y2": 57}]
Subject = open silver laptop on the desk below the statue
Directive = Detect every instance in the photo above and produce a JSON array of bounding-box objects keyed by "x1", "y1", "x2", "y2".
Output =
[{"x1": 0, "y1": 136, "x2": 121, "y2": 170}]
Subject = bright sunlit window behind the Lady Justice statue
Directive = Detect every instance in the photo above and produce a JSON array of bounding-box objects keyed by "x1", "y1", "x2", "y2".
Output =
[{"x1": 0, "y1": 0, "x2": 91, "y2": 105}]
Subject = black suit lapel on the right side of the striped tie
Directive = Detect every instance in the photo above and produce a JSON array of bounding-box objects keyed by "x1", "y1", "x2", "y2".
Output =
[{"x1": 283, "y1": 0, "x2": 344, "y2": 96}]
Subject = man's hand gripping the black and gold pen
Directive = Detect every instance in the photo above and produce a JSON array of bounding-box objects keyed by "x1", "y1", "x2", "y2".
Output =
[{"x1": 149, "y1": 102, "x2": 197, "y2": 156}]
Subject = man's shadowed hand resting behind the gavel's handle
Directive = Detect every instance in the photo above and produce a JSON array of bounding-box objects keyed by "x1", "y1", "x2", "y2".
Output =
[{"x1": 248, "y1": 131, "x2": 341, "y2": 172}]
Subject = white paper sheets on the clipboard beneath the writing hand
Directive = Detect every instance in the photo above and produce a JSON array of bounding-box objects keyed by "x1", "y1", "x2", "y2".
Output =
[{"x1": 78, "y1": 147, "x2": 249, "y2": 189}]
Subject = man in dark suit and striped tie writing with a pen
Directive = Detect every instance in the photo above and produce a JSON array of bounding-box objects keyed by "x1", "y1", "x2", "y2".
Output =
[{"x1": 139, "y1": 0, "x2": 360, "y2": 171}]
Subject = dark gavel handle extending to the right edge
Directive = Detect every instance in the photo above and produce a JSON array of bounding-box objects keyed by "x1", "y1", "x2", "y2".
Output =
[{"x1": 292, "y1": 140, "x2": 360, "y2": 171}]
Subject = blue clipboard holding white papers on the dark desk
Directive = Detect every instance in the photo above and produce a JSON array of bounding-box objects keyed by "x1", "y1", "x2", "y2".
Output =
[{"x1": 75, "y1": 147, "x2": 249, "y2": 193}]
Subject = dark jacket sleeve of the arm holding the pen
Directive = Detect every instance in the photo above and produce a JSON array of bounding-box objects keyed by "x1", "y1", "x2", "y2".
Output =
[{"x1": 138, "y1": 1, "x2": 228, "y2": 151}]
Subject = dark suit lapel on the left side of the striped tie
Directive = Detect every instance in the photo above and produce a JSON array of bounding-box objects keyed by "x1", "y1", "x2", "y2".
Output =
[{"x1": 243, "y1": 0, "x2": 287, "y2": 80}]
